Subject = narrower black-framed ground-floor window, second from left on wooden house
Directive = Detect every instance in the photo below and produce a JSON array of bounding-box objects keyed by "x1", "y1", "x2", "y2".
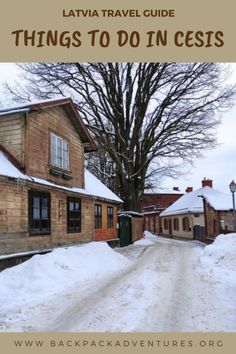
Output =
[{"x1": 67, "y1": 197, "x2": 81, "y2": 233}]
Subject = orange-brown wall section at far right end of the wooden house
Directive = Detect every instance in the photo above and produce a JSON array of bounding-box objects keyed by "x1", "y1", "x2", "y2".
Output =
[{"x1": 94, "y1": 201, "x2": 118, "y2": 241}]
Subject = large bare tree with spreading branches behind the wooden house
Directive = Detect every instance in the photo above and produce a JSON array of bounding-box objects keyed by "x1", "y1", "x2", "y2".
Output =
[{"x1": 4, "y1": 63, "x2": 234, "y2": 210}]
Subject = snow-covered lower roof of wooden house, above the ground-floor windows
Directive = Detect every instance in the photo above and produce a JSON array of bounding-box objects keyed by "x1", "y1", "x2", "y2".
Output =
[{"x1": 0, "y1": 151, "x2": 123, "y2": 204}]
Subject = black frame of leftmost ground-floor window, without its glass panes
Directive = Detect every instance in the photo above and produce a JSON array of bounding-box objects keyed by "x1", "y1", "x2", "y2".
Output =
[{"x1": 28, "y1": 190, "x2": 51, "y2": 236}]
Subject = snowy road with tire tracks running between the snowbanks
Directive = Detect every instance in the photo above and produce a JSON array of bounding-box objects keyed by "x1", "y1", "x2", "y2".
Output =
[{"x1": 47, "y1": 239, "x2": 233, "y2": 332}]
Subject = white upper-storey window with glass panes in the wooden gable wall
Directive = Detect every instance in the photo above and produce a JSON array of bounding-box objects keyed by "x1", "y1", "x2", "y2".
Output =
[{"x1": 50, "y1": 133, "x2": 69, "y2": 170}]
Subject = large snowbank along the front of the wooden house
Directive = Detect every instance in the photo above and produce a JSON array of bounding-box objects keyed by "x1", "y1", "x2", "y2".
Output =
[{"x1": 0, "y1": 242, "x2": 129, "y2": 309}]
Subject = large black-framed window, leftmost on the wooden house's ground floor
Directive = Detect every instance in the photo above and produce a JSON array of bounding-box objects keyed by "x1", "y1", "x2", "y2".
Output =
[{"x1": 29, "y1": 191, "x2": 51, "y2": 235}]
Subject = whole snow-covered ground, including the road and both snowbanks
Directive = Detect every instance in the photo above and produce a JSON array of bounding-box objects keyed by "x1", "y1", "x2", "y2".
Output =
[{"x1": 0, "y1": 233, "x2": 236, "y2": 332}]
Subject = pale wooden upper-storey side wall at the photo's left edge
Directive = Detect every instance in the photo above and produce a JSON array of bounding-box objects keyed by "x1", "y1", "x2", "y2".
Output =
[{"x1": 0, "y1": 113, "x2": 25, "y2": 166}]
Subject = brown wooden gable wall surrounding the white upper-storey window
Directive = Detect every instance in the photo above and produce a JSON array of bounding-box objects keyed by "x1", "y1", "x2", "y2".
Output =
[{"x1": 26, "y1": 107, "x2": 84, "y2": 187}]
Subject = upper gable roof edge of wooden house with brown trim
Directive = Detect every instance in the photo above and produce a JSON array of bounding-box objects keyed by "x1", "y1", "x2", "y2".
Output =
[{"x1": 0, "y1": 97, "x2": 96, "y2": 152}]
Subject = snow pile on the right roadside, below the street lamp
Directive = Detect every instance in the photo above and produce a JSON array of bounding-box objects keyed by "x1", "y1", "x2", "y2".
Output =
[{"x1": 200, "y1": 234, "x2": 236, "y2": 272}]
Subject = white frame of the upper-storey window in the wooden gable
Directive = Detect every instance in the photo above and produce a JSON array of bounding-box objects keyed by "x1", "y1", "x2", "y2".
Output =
[{"x1": 50, "y1": 131, "x2": 70, "y2": 171}]
